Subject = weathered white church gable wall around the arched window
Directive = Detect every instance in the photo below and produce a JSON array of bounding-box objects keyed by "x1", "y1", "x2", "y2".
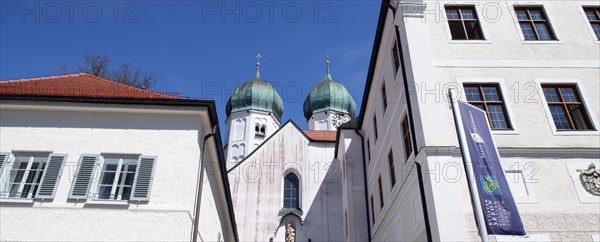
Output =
[{"x1": 229, "y1": 123, "x2": 343, "y2": 241}]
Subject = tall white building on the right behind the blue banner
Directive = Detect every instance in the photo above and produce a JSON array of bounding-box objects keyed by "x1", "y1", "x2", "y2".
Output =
[{"x1": 336, "y1": 1, "x2": 600, "y2": 241}]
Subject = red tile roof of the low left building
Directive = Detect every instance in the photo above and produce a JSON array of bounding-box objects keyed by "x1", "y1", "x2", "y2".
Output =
[{"x1": 0, "y1": 73, "x2": 181, "y2": 99}]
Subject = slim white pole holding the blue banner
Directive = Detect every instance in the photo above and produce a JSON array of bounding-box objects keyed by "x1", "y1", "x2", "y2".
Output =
[{"x1": 448, "y1": 88, "x2": 488, "y2": 242}]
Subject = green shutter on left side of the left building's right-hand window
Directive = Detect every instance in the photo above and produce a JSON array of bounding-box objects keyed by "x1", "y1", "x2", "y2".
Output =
[{"x1": 69, "y1": 155, "x2": 100, "y2": 200}]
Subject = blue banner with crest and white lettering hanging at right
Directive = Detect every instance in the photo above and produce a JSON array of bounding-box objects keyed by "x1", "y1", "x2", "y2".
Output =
[{"x1": 458, "y1": 102, "x2": 526, "y2": 235}]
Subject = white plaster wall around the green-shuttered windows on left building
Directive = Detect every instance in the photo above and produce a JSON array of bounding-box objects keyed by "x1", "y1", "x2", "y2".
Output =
[{"x1": 0, "y1": 104, "x2": 222, "y2": 241}]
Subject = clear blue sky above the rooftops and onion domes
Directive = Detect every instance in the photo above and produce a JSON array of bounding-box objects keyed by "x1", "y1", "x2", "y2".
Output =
[{"x1": 0, "y1": 0, "x2": 380, "y2": 136}]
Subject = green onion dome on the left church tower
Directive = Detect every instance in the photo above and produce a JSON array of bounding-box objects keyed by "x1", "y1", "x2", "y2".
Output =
[{"x1": 226, "y1": 69, "x2": 283, "y2": 120}]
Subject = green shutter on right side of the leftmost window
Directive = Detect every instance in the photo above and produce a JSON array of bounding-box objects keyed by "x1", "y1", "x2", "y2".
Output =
[{"x1": 35, "y1": 154, "x2": 67, "y2": 199}]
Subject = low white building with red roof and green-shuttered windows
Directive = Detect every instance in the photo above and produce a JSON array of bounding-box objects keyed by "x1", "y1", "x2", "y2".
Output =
[{"x1": 0, "y1": 74, "x2": 237, "y2": 241}]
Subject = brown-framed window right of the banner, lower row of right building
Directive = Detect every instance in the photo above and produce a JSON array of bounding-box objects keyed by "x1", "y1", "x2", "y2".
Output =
[{"x1": 542, "y1": 84, "x2": 593, "y2": 130}]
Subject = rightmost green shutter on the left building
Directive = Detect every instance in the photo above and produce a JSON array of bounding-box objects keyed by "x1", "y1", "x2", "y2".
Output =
[{"x1": 129, "y1": 156, "x2": 156, "y2": 202}]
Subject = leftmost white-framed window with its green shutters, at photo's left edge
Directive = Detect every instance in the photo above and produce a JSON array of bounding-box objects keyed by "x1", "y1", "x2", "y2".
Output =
[{"x1": 0, "y1": 152, "x2": 66, "y2": 199}]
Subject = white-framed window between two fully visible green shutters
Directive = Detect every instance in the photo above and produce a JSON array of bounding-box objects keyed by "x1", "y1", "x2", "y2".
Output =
[{"x1": 96, "y1": 155, "x2": 139, "y2": 200}]
